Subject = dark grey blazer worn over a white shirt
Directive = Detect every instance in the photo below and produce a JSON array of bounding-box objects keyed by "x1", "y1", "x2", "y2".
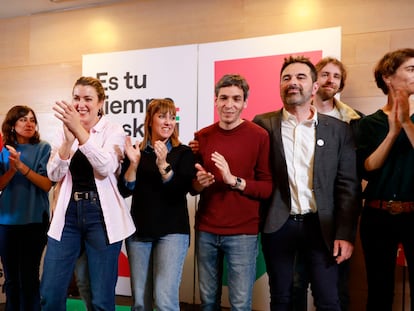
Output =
[{"x1": 253, "y1": 110, "x2": 360, "y2": 250}]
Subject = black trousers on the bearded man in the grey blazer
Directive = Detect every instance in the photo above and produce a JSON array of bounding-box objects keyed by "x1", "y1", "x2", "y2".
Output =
[{"x1": 262, "y1": 214, "x2": 340, "y2": 311}]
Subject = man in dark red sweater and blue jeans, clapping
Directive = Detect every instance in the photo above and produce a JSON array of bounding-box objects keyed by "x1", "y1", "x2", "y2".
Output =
[{"x1": 194, "y1": 75, "x2": 272, "y2": 311}]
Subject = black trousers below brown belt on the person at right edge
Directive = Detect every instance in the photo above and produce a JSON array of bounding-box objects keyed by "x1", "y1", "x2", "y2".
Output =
[{"x1": 360, "y1": 207, "x2": 414, "y2": 311}]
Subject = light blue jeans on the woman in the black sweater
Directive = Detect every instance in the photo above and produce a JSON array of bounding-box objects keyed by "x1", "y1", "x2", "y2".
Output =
[{"x1": 125, "y1": 234, "x2": 189, "y2": 311}]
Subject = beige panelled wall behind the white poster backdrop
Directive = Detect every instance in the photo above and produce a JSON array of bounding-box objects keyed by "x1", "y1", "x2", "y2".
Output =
[{"x1": 0, "y1": 0, "x2": 414, "y2": 311}]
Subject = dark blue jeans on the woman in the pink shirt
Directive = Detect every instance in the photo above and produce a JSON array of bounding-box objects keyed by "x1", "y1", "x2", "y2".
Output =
[{"x1": 40, "y1": 199, "x2": 122, "y2": 311}]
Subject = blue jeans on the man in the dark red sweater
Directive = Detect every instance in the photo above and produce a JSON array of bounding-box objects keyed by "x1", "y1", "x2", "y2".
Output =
[{"x1": 196, "y1": 231, "x2": 258, "y2": 311}]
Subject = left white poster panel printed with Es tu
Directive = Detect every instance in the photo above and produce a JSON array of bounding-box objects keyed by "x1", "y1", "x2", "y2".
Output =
[{"x1": 82, "y1": 45, "x2": 197, "y2": 302}]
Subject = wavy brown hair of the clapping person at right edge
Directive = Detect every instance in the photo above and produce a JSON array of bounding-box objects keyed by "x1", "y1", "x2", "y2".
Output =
[{"x1": 374, "y1": 48, "x2": 414, "y2": 95}]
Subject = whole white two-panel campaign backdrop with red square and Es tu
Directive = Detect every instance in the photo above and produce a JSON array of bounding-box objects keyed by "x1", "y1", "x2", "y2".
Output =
[{"x1": 83, "y1": 27, "x2": 341, "y2": 310}]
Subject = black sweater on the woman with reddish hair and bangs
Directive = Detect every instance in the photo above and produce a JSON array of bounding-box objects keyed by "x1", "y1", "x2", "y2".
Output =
[{"x1": 118, "y1": 145, "x2": 196, "y2": 238}]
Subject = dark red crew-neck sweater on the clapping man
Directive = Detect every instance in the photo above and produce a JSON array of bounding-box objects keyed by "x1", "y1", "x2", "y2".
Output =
[{"x1": 195, "y1": 120, "x2": 272, "y2": 235}]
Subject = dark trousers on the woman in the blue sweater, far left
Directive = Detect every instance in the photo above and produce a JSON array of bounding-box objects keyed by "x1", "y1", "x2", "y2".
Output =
[{"x1": 0, "y1": 221, "x2": 48, "y2": 311}]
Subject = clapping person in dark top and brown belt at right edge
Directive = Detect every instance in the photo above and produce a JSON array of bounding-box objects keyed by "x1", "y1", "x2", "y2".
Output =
[{"x1": 357, "y1": 49, "x2": 414, "y2": 311}]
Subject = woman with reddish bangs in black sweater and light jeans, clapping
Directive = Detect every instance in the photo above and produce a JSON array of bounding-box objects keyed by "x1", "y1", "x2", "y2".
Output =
[{"x1": 119, "y1": 99, "x2": 195, "y2": 311}]
